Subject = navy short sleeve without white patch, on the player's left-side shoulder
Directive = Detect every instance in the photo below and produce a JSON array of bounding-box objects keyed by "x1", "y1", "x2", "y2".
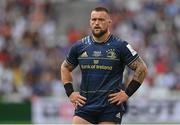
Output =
[{"x1": 66, "y1": 44, "x2": 78, "y2": 67}]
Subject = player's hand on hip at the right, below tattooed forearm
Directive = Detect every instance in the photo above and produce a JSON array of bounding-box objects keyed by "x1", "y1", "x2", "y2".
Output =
[{"x1": 108, "y1": 90, "x2": 129, "y2": 105}]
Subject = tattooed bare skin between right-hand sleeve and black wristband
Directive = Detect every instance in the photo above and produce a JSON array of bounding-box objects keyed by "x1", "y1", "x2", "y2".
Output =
[{"x1": 128, "y1": 57, "x2": 147, "y2": 83}]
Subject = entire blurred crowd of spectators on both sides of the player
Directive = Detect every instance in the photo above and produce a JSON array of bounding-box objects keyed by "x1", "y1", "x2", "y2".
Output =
[{"x1": 0, "y1": 0, "x2": 180, "y2": 100}]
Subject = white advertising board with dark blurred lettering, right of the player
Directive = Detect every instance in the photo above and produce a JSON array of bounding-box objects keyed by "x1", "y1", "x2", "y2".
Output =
[{"x1": 123, "y1": 98, "x2": 180, "y2": 123}]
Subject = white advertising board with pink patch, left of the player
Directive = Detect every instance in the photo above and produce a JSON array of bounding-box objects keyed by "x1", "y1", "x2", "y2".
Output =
[{"x1": 32, "y1": 98, "x2": 74, "y2": 124}]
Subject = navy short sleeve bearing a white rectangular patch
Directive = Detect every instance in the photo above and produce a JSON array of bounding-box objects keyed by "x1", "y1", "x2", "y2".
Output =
[{"x1": 121, "y1": 41, "x2": 139, "y2": 65}]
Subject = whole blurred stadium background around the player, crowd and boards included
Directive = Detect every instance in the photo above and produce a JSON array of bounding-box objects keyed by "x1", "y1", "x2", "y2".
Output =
[{"x1": 0, "y1": 0, "x2": 180, "y2": 124}]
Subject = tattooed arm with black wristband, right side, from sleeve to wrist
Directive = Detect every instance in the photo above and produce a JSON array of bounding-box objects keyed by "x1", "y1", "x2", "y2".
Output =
[{"x1": 125, "y1": 57, "x2": 148, "y2": 97}]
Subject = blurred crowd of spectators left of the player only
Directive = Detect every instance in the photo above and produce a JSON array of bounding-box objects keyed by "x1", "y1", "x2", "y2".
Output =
[{"x1": 0, "y1": 0, "x2": 64, "y2": 100}]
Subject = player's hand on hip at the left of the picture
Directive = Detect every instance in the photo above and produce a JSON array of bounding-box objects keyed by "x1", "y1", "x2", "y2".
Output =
[{"x1": 69, "y1": 92, "x2": 86, "y2": 108}]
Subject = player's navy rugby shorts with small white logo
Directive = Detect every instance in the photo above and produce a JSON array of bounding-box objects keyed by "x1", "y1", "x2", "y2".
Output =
[{"x1": 74, "y1": 104, "x2": 124, "y2": 124}]
